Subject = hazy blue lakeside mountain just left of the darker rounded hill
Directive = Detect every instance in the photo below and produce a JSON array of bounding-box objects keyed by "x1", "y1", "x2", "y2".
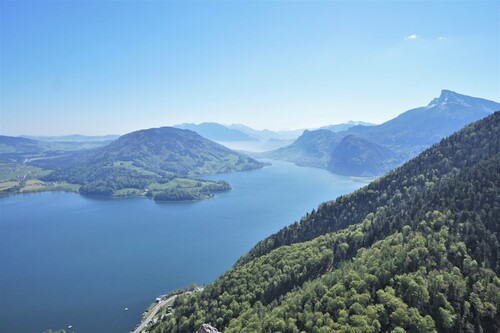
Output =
[{"x1": 263, "y1": 129, "x2": 343, "y2": 168}]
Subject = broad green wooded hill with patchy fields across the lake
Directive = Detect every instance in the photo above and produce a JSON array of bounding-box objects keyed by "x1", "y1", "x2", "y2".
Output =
[{"x1": 36, "y1": 127, "x2": 264, "y2": 196}]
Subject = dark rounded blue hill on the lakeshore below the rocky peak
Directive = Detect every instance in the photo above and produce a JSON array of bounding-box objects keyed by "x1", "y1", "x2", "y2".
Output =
[{"x1": 327, "y1": 135, "x2": 396, "y2": 177}]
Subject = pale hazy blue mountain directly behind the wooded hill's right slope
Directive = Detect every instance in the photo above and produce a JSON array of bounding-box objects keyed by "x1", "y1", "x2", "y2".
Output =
[{"x1": 174, "y1": 123, "x2": 256, "y2": 141}]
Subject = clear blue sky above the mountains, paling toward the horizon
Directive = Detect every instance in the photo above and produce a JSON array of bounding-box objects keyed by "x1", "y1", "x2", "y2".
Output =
[{"x1": 0, "y1": 1, "x2": 500, "y2": 135}]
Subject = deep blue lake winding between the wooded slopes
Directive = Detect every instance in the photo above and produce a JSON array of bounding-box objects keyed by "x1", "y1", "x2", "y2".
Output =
[{"x1": 0, "y1": 162, "x2": 363, "y2": 333}]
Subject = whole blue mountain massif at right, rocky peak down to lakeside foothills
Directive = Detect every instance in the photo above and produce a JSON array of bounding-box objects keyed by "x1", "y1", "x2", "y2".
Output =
[{"x1": 261, "y1": 90, "x2": 500, "y2": 176}]
